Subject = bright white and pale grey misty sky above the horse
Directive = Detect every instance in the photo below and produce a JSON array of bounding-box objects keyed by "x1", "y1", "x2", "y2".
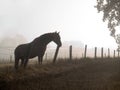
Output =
[{"x1": 0, "y1": 0, "x2": 117, "y2": 48}]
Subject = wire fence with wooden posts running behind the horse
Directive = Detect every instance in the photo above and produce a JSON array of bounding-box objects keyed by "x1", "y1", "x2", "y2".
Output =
[{"x1": 0, "y1": 45, "x2": 119, "y2": 63}]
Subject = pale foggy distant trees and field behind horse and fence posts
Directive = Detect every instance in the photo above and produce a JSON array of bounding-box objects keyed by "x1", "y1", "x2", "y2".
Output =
[{"x1": 0, "y1": 34, "x2": 114, "y2": 60}]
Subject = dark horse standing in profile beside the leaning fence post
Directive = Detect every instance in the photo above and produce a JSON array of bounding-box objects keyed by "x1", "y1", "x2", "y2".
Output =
[{"x1": 14, "y1": 32, "x2": 62, "y2": 69}]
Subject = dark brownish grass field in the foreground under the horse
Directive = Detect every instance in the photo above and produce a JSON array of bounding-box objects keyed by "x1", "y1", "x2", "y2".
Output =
[{"x1": 0, "y1": 59, "x2": 120, "y2": 90}]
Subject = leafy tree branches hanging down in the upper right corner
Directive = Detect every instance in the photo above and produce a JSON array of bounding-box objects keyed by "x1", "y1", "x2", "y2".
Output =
[{"x1": 95, "y1": 0, "x2": 120, "y2": 48}]
